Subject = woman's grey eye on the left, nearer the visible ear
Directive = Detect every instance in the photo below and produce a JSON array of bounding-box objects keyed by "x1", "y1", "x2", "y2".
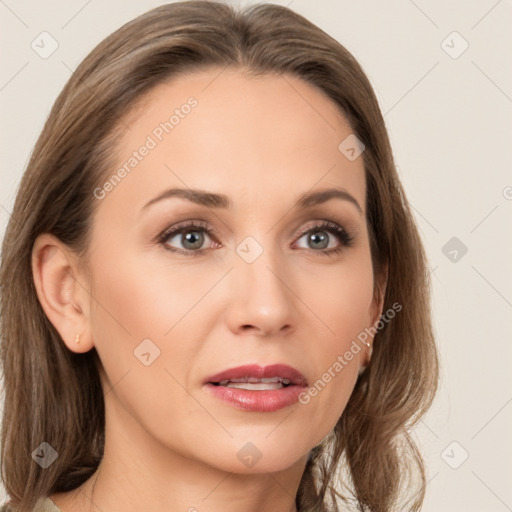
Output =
[{"x1": 159, "y1": 221, "x2": 219, "y2": 255}]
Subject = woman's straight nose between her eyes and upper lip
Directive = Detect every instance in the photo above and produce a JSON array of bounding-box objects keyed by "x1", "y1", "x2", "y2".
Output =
[{"x1": 226, "y1": 242, "x2": 298, "y2": 337}]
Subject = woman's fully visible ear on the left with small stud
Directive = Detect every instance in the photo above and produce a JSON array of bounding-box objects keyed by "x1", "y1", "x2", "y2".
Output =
[{"x1": 32, "y1": 233, "x2": 94, "y2": 353}]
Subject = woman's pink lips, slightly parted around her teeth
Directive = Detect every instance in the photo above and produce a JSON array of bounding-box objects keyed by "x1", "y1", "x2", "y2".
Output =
[{"x1": 203, "y1": 364, "x2": 308, "y2": 412}]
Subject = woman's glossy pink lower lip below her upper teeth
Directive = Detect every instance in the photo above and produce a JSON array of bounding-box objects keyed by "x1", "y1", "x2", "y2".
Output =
[{"x1": 206, "y1": 383, "x2": 307, "y2": 412}]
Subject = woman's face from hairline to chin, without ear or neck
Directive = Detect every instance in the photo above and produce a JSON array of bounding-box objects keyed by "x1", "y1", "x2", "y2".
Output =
[{"x1": 83, "y1": 69, "x2": 379, "y2": 472}]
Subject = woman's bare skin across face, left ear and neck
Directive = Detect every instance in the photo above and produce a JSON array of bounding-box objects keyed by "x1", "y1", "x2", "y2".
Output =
[{"x1": 33, "y1": 69, "x2": 382, "y2": 512}]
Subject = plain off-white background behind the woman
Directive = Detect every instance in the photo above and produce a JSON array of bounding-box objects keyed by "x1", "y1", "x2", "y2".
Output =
[{"x1": 0, "y1": 0, "x2": 512, "y2": 512}]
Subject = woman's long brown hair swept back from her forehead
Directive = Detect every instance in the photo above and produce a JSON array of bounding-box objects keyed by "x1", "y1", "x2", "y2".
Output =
[{"x1": 0, "y1": 1, "x2": 439, "y2": 512}]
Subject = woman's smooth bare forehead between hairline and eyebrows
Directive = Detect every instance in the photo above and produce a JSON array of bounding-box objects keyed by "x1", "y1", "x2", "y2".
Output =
[{"x1": 98, "y1": 68, "x2": 365, "y2": 214}]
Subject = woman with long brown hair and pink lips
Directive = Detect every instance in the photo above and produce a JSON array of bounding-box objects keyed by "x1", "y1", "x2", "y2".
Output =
[{"x1": 1, "y1": 1, "x2": 438, "y2": 512}]
